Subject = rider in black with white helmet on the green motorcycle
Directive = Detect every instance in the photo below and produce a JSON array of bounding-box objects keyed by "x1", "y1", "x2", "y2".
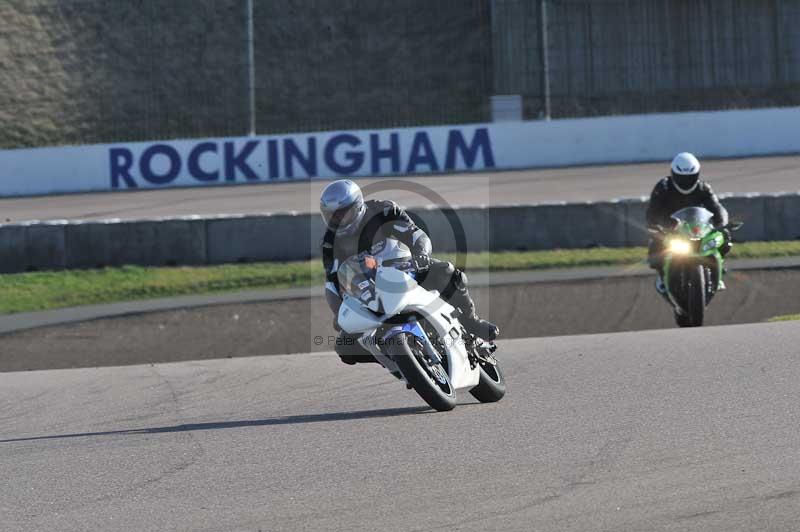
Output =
[{"x1": 647, "y1": 153, "x2": 731, "y2": 294}]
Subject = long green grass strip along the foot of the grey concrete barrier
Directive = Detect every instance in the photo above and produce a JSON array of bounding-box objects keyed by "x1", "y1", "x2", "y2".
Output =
[{"x1": 0, "y1": 241, "x2": 800, "y2": 314}]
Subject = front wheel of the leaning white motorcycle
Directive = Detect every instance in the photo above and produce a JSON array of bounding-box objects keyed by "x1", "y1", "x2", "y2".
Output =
[{"x1": 387, "y1": 333, "x2": 456, "y2": 412}]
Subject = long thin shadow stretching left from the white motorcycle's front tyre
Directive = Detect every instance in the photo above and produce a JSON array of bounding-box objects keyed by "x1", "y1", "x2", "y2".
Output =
[{"x1": 0, "y1": 406, "x2": 433, "y2": 443}]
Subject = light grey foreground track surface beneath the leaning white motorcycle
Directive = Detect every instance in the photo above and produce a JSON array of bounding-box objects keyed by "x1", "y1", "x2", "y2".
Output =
[{"x1": 0, "y1": 323, "x2": 800, "y2": 532}]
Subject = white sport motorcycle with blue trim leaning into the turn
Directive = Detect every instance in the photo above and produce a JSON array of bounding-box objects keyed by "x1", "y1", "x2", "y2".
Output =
[{"x1": 338, "y1": 239, "x2": 506, "y2": 411}]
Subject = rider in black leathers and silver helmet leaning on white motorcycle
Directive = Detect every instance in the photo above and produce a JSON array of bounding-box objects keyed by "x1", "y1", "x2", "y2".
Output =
[{"x1": 320, "y1": 180, "x2": 499, "y2": 364}]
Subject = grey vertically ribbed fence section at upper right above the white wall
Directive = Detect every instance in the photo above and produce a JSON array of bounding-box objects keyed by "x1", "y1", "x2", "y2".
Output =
[{"x1": 492, "y1": 0, "x2": 800, "y2": 118}]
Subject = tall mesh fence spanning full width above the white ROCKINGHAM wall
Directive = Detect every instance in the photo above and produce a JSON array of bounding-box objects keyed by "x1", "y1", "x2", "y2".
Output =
[{"x1": 0, "y1": 0, "x2": 800, "y2": 147}]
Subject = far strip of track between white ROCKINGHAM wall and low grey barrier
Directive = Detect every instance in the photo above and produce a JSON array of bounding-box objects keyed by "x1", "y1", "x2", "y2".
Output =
[{"x1": 0, "y1": 156, "x2": 800, "y2": 222}]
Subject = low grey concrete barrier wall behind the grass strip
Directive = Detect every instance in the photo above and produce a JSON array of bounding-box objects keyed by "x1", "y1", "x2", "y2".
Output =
[{"x1": 0, "y1": 194, "x2": 800, "y2": 273}]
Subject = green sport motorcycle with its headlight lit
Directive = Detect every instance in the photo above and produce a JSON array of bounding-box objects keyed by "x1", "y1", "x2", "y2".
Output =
[{"x1": 648, "y1": 207, "x2": 742, "y2": 327}]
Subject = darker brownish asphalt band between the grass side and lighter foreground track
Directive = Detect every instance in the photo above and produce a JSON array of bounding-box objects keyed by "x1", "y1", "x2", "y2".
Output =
[{"x1": 0, "y1": 269, "x2": 800, "y2": 371}]
